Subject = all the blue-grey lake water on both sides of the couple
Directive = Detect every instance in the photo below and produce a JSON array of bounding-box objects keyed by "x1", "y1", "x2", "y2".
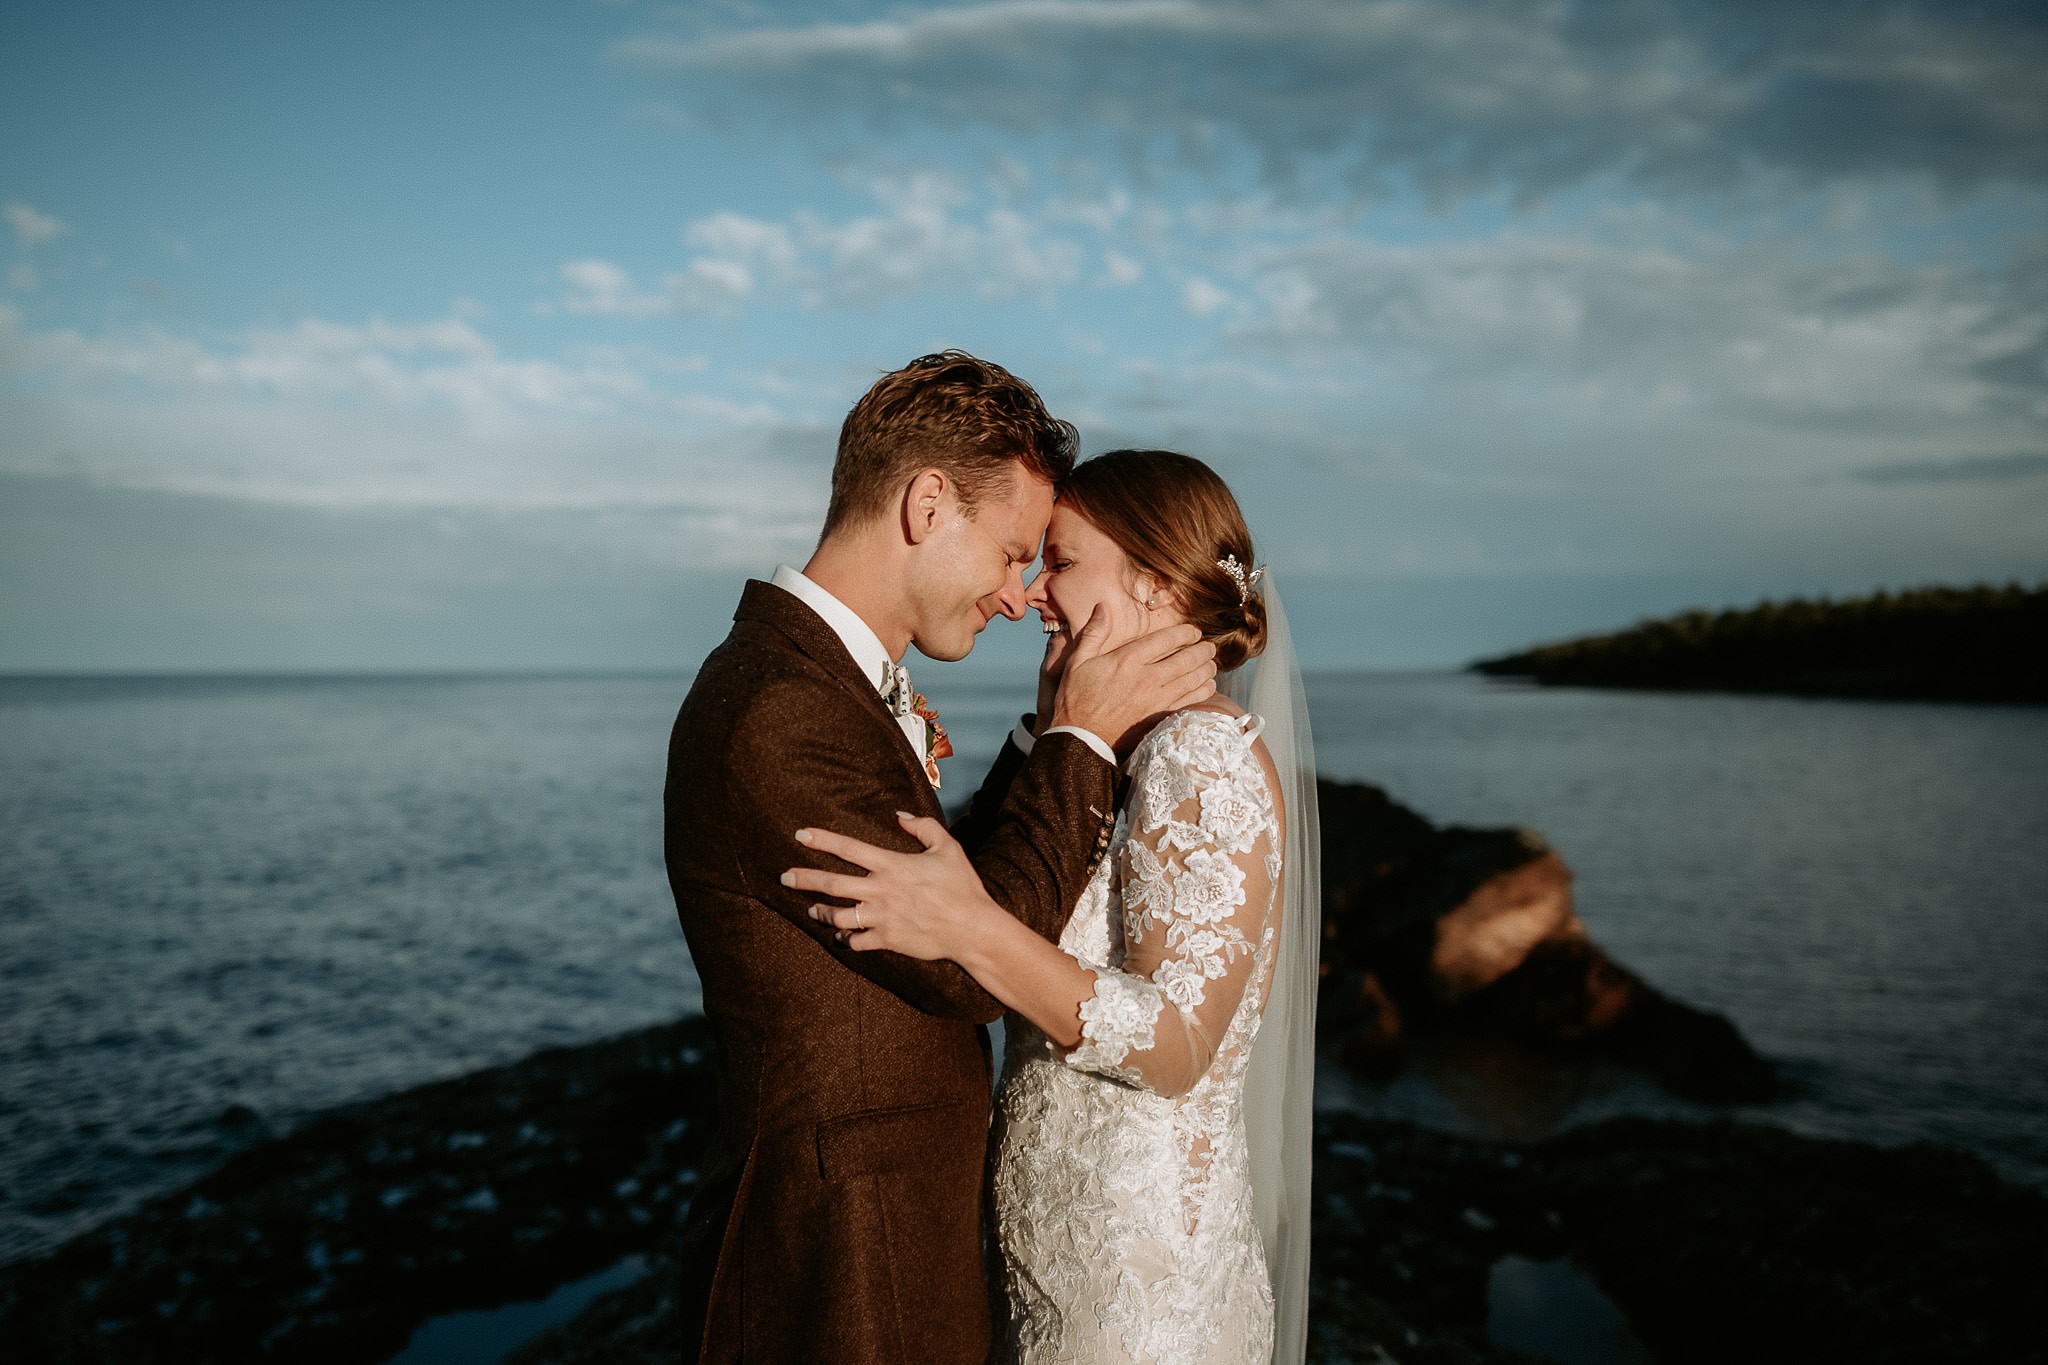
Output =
[{"x1": 0, "y1": 665, "x2": 2048, "y2": 1261}]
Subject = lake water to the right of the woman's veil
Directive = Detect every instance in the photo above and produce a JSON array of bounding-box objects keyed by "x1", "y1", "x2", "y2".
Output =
[{"x1": 1311, "y1": 675, "x2": 2048, "y2": 1185}]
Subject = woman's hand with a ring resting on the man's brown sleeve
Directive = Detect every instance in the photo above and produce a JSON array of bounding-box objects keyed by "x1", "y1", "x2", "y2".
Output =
[{"x1": 782, "y1": 810, "x2": 1004, "y2": 960}]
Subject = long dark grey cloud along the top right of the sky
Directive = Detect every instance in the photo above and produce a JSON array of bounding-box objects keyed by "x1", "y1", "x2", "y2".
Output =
[{"x1": 618, "y1": 0, "x2": 2048, "y2": 194}]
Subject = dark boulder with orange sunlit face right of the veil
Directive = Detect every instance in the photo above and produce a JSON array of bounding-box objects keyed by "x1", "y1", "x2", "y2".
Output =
[{"x1": 1317, "y1": 782, "x2": 1778, "y2": 1103}]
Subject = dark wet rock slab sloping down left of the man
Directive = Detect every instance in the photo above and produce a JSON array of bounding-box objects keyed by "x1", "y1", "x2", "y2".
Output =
[{"x1": 0, "y1": 1019, "x2": 713, "y2": 1365}]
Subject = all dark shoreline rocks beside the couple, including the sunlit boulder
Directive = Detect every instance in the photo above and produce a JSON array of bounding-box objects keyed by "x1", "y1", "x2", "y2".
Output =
[{"x1": 0, "y1": 782, "x2": 2048, "y2": 1365}]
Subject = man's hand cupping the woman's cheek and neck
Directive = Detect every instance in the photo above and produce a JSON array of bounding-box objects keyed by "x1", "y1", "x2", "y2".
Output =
[{"x1": 1038, "y1": 608, "x2": 1217, "y2": 753}]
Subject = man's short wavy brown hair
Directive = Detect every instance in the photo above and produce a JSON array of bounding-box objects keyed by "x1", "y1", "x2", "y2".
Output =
[{"x1": 825, "y1": 350, "x2": 1079, "y2": 536}]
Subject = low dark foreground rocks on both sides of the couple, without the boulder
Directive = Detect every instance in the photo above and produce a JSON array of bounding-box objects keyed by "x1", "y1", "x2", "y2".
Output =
[{"x1": 0, "y1": 1019, "x2": 2048, "y2": 1365}]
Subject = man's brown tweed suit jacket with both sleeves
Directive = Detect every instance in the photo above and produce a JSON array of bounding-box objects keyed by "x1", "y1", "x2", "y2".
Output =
[{"x1": 666, "y1": 581, "x2": 1116, "y2": 1365}]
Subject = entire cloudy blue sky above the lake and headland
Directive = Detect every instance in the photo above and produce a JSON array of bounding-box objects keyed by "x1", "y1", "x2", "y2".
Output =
[{"x1": 0, "y1": 0, "x2": 2048, "y2": 669}]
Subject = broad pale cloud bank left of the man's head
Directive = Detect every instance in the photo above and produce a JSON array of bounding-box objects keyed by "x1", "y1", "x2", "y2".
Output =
[{"x1": 0, "y1": 305, "x2": 829, "y2": 565}]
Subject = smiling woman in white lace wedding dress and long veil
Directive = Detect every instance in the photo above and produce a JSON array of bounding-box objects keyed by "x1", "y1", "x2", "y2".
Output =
[{"x1": 797, "y1": 450, "x2": 1319, "y2": 1365}]
